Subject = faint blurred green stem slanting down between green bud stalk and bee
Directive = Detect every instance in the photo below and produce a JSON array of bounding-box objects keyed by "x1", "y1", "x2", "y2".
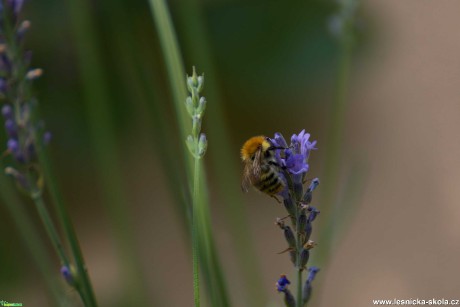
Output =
[{"x1": 174, "y1": 0, "x2": 268, "y2": 306}]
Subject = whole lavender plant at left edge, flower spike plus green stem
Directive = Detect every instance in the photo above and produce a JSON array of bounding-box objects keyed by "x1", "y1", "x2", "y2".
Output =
[{"x1": 0, "y1": 0, "x2": 96, "y2": 306}]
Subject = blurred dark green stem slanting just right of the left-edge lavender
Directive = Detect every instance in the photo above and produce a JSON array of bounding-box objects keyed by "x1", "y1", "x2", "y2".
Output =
[{"x1": 66, "y1": 0, "x2": 151, "y2": 306}]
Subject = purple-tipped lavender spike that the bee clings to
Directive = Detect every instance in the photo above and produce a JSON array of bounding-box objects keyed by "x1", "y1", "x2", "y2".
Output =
[{"x1": 271, "y1": 130, "x2": 319, "y2": 307}]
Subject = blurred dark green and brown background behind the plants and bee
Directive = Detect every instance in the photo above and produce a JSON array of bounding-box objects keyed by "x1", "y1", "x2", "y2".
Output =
[{"x1": 0, "y1": 0, "x2": 460, "y2": 306}]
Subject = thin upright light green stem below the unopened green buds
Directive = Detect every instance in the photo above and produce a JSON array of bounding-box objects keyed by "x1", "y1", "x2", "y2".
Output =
[{"x1": 192, "y1": 156, "x2": 200, "y2": 307}]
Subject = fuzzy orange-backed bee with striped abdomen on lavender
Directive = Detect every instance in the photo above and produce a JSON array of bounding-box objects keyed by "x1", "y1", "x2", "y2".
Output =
[{"x1": 241, "y1": 136, "x2": 286, "y2": 198}]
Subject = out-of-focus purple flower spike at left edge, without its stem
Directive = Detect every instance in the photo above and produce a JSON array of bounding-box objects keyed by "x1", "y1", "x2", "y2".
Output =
[{"x1": 0, "y1": 0, "x2": 51, "y2": 194}]
